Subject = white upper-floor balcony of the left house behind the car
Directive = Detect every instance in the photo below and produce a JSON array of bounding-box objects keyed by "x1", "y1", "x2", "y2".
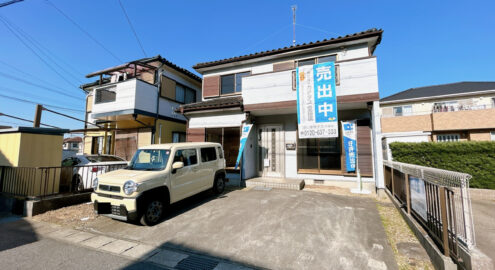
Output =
[{"x1": 88, "y1": 78, "x2": 186, "y2": 122}]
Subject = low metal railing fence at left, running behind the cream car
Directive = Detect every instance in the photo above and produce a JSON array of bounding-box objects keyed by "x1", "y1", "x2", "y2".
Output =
[{"x1": 0, "y1": 164, "x2": 127, "y2": 198}]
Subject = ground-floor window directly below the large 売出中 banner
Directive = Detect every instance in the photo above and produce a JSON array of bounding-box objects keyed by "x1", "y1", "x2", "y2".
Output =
[{"x1": 297, "y1": 137, "x2": 342, "y2": 173}]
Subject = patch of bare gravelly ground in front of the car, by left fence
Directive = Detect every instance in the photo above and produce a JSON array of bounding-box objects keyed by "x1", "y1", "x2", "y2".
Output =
[{"x1": 33, "y1": 202, "x2": 100, "y2": 227}]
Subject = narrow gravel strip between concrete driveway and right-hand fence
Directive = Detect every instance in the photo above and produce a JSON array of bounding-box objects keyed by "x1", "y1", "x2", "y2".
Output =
[{"x1": 377, "y1": 197, "x2": 435, "y2": 269}]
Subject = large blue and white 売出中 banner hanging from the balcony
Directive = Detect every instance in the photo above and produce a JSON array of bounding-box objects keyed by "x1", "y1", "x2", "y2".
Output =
[{"x1": 296, "y1": 62, "x2": 339, "y2": 139}]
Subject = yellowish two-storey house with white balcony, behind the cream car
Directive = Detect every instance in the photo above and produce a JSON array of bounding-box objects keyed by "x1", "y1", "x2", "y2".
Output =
[{"x1": 81, "y1": 55, "x2": 201, "y2": 160}]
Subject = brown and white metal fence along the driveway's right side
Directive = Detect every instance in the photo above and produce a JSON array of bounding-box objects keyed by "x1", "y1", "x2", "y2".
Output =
[{"x1": 384, "y1": 160, "x2": 476, "y2": 259}]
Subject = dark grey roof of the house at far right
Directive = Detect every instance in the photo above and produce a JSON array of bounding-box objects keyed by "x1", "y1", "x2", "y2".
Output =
[{"x1": 380, "y1": 82, "x2": 495, "y2": 102}]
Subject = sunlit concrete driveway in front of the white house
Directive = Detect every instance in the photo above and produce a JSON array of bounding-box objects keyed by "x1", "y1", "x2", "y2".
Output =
[{"x1": 84, "y1": 189, "x2": 397, "y2": 269}]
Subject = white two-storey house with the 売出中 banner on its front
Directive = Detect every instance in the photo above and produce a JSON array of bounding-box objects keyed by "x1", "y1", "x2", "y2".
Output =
[{"x1": 179, "y1": 29, "x2": 383, "y2": 188}]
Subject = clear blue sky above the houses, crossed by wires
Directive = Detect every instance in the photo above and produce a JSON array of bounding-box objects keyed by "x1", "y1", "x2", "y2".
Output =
[{"x1": 0, "y1": 0, "x2": 495, "y2": 129}]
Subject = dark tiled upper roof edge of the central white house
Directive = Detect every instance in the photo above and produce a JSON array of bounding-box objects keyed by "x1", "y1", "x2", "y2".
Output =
[{"x1": 193, "y1": 28, "x2": 383, "y2": 69}]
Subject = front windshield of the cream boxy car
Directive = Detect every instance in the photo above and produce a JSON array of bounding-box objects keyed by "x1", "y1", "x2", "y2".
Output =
[{"x1": 127, "y1": 149, "x2": 170, "y2": 171}]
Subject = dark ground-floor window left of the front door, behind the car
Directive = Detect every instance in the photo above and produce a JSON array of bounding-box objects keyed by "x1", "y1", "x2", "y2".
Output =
[{"x1": 205, "y1": 127, "x2": 241, "y2": 169}]
